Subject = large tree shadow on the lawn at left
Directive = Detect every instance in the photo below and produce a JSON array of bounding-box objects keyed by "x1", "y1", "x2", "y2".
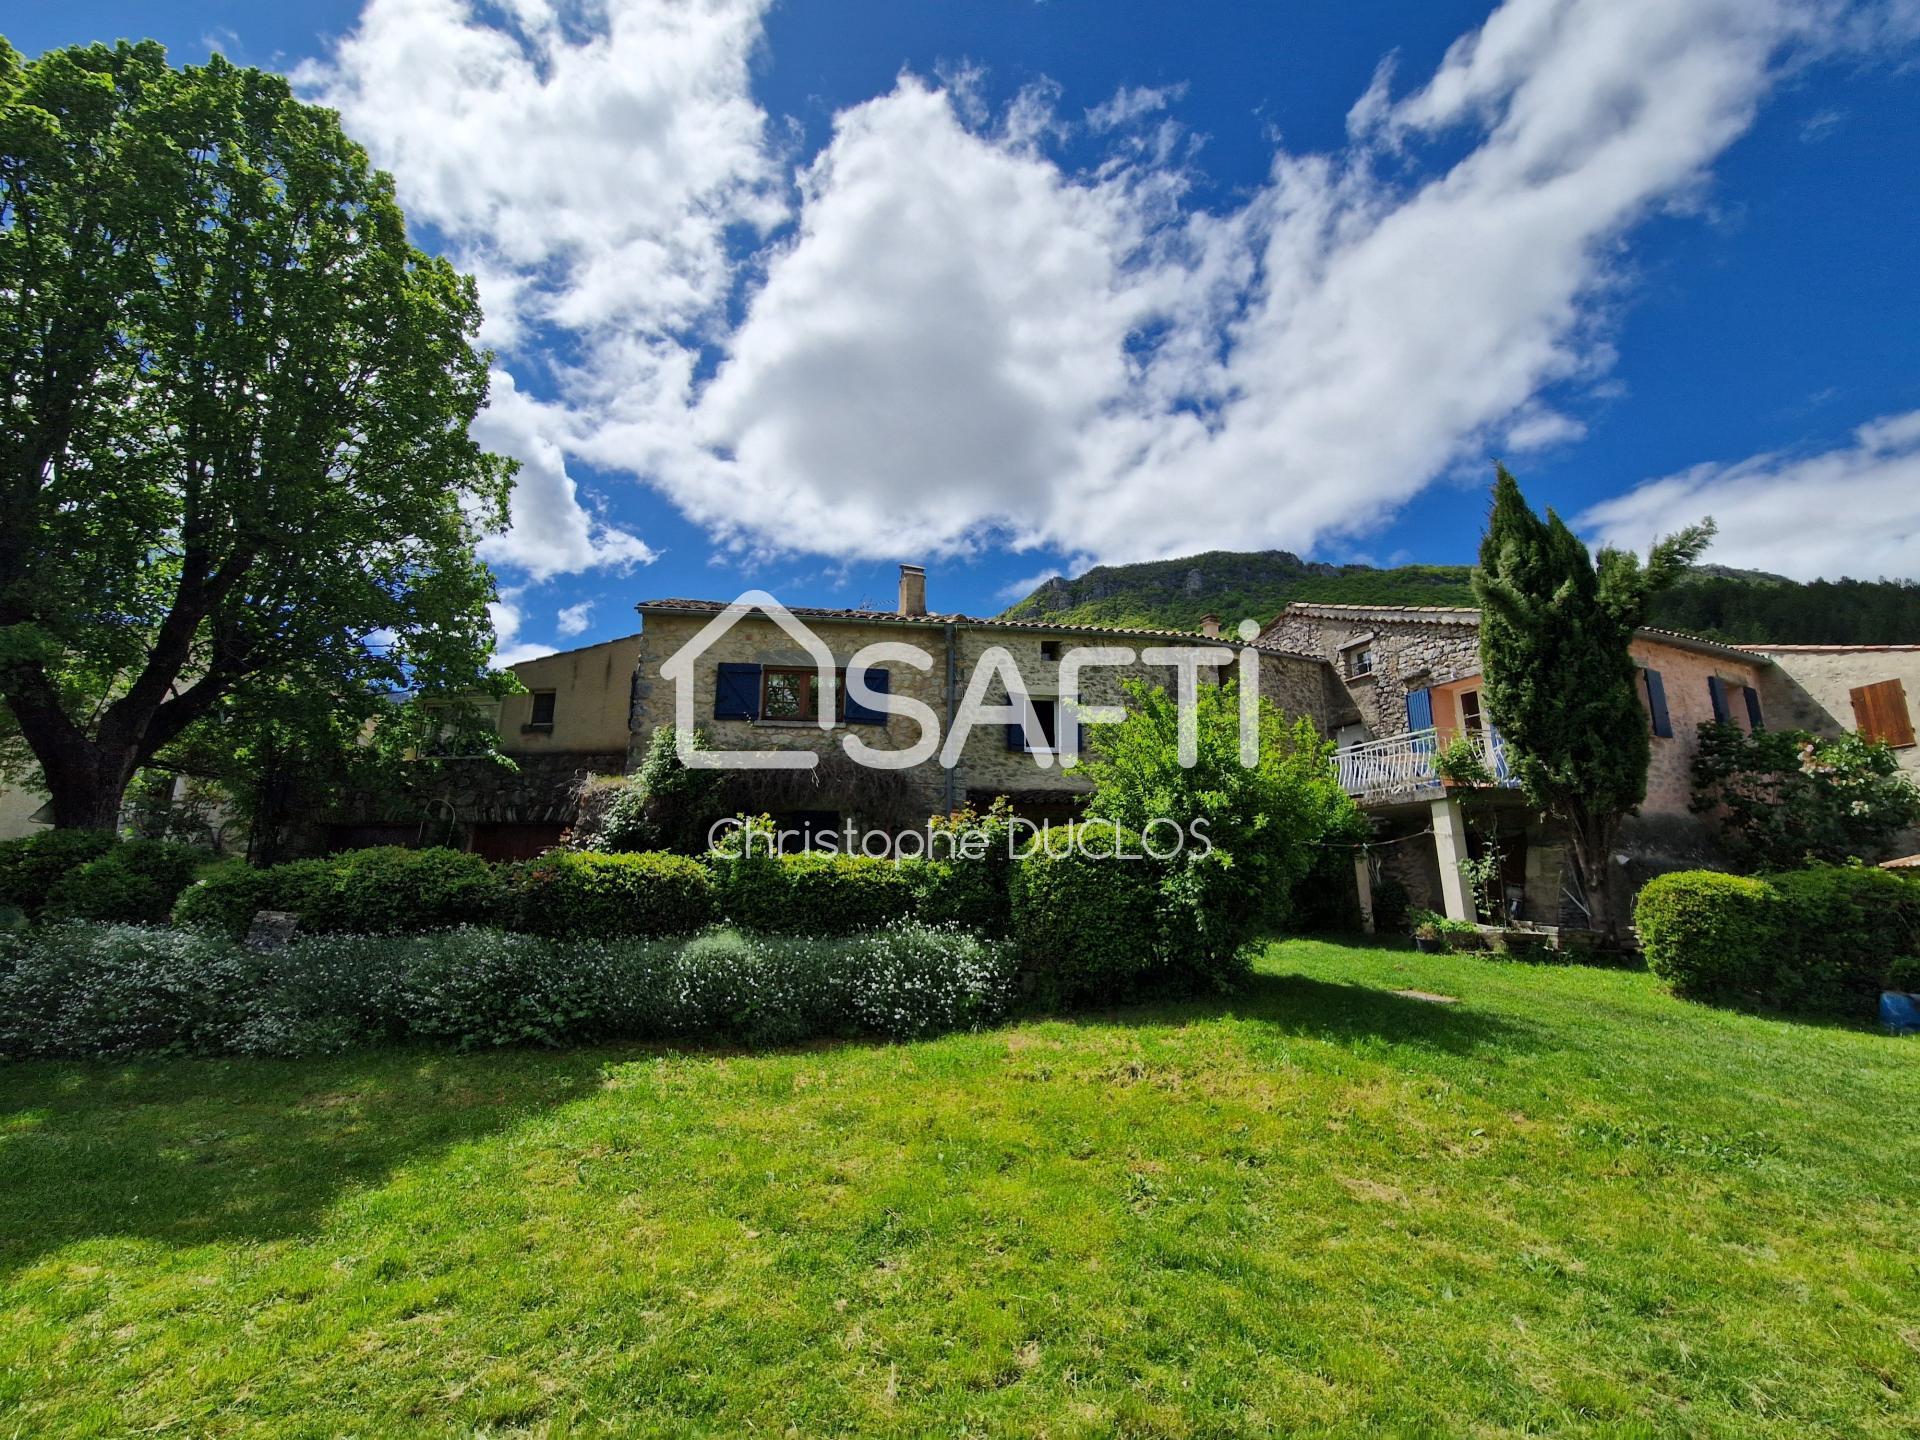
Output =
[{"x1": 0, "y1": 1050, "x2": 607, "y2": 1273}]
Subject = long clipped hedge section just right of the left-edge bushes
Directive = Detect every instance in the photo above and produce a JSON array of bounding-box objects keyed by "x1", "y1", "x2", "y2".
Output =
[{"x1": 173, "y1": 845, "x2": 507, "y2": 939}]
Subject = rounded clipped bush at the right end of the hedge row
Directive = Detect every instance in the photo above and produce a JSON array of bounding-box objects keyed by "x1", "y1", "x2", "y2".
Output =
[{"x1": 1010, "y1": 822, "x2": 1160, "y2": 1000}]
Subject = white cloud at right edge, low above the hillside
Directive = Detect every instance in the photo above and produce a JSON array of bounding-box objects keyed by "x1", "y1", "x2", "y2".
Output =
[{"x1": 1576, "y1": 411, "x2": 1920, "y2": 580}]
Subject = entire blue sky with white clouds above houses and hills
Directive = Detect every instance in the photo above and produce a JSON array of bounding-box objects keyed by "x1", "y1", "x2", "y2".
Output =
[{"x1": 8, "y1": 0, "x2": 1920, "y2": 657}]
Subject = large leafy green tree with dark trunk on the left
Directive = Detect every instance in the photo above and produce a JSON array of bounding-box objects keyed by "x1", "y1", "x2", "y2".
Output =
[{"x1": 0, "y1": 40, "x2": 513, "y2": 828}]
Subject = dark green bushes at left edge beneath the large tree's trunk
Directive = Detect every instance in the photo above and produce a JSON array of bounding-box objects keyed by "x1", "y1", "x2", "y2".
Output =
[{"x1": 0, "y1": 829, "x2": 215, "y2": 925}]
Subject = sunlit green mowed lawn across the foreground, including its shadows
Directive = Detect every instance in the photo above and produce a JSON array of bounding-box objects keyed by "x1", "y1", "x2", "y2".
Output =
[{"x1": 0, "y1": 941, "x2": 1920, "y2": 1436}]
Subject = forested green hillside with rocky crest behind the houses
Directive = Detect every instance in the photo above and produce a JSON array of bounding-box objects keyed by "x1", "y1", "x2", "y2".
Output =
[{"x1": 1004, "y1": 549, "x2": 1920, "y2": 645}]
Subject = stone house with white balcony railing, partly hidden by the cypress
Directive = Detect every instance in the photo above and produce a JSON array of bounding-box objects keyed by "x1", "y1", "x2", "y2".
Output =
[{"x1": 1260, "y1": 605, "x2": 1772, "y2": 925}]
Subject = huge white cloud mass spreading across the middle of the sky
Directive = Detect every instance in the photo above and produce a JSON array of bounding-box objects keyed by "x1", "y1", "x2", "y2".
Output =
[{"x1": 301, "y1": 0, "x2": 1884, "y2": 574}]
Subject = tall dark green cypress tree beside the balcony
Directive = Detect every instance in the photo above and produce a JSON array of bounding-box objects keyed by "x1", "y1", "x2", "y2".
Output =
[{"x1": 1473, "y1": 465, "x2": 1713, "y2": 935}]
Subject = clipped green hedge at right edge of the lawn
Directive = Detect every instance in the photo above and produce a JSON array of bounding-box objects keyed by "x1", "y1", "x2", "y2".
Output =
[{"x1": 1634, "y1": 866, "x2": 1920, "y2": 1014}]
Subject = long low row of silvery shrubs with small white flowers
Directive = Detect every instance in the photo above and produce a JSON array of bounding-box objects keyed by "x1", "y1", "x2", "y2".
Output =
[{"x1": 0, "y1": 924, "x2": 1016, "y2": 1058}]
